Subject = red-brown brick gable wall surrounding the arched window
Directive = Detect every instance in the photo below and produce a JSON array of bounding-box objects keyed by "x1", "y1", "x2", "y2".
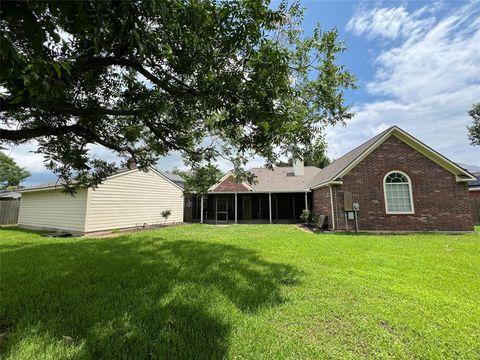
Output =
[{"x1": 314, "y1": 136, "x2": 473, "y2": 231}]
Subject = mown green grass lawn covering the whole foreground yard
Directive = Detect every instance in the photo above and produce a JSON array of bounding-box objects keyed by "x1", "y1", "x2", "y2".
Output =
[{"x1": 0, "y1": 225, "x2": 480, "y2": 360}]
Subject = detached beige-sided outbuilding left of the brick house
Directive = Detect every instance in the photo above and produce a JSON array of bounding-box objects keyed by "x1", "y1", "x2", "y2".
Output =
[{"x1": 18, "y1": 168, "x2": 183, "y2": 235}]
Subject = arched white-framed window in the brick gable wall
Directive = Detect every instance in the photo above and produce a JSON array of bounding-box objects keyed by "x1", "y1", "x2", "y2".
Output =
[{"x1": 383, "y1": 171, "x2": 414, "y2": 214}]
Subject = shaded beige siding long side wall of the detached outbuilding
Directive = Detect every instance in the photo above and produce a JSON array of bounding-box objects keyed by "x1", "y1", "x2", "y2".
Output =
[{"x1": 18, "y1": 189, "x2": 87, "y2": 232}]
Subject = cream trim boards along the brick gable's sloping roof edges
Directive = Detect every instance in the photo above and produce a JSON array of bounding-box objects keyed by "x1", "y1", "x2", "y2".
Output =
[{"x1": 330, "y1": 126, "x2": 476, "y2": 183}]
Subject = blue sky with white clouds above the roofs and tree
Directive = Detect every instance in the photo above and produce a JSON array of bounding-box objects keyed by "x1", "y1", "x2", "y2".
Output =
[{"x1": 5, "y1": 0, "x2": 480, "y2": 186}]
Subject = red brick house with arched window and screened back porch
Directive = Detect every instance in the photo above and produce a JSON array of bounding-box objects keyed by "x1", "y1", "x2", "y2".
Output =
[{"x1": 188, "y1": 126, "x2": 476, "y2": 231}]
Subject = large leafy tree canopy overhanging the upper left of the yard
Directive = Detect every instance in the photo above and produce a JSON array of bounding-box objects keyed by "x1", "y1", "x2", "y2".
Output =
[{"x1": 0, "y1": 0, "x2": 355, "y2": 191}]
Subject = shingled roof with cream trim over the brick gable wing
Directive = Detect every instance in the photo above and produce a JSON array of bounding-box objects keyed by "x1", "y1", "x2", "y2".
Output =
[{"x1": 309, "y1": 126, "x2": 475, "y2": 188}]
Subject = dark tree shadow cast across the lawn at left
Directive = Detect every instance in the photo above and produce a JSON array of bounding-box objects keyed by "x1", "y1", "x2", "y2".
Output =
[{"x1": 0, "y1": 234, "x2": 300, "y2": 359}]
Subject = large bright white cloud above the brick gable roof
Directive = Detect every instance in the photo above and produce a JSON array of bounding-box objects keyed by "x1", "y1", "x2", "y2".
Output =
[{"x1": 338, "y1": 2, "x2": 480, "y2": 165}]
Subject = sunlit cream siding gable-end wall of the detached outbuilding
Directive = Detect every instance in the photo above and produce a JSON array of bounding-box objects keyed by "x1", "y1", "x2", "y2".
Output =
[{"x1": 86, "y1": 170, "x2": 183, "y2": 232}]
